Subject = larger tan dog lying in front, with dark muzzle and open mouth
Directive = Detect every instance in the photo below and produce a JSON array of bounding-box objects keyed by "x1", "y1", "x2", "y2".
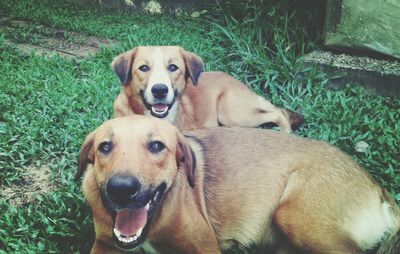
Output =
[{"x1": 76, "y1": 115, "x2": 400, "y2": 254}]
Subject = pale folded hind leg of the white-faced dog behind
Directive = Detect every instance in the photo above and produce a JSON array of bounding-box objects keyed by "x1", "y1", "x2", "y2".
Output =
[{"x1": 217, "y1": 94, "x2": 294, "y2": 133}]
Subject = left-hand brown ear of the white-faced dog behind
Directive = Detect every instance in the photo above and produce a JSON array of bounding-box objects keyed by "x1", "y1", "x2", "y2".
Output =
[{"x1": 111, "y1": 48, "x2": 137, "y2": 85}]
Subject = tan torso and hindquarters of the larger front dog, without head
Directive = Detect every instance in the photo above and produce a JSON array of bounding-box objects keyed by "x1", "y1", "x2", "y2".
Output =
[{"x1": 191, "y1": 128, "x2": 400, "y2": 253}]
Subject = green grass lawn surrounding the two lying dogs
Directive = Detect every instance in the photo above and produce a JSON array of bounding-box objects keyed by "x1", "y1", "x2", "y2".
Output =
[{"x1": 0, "y1": 0, "x2": 400, "y2": 253}]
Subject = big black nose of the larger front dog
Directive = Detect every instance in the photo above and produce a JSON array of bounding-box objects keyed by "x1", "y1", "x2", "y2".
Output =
[{"x1": 107, "y1": 175, "x2": 140, "y2": 205}]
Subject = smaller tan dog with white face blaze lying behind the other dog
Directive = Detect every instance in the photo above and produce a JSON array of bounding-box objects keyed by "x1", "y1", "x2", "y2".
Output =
[{"x1": 112, "y1": 46, "x2": 303, "y2": 132}]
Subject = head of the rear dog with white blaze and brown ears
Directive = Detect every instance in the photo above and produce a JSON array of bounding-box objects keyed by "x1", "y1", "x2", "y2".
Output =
[{"x1": 111, "y1": 46, "x2": 204, "y2": 119}]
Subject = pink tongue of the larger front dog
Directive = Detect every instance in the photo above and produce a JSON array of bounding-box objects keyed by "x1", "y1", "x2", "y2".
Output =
[{"x1": 115, "y1": 207, "x2": 147, "y2": 236}]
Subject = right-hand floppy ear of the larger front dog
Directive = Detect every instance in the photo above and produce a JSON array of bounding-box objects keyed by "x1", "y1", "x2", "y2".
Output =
[{"x1": 176, "y1": 131, "x2": 196, "y2": 188}]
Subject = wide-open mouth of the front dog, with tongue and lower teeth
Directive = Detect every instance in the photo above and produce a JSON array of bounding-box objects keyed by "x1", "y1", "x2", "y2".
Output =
[{"x1": 113, "y1": 184, "x2": 165, "y2": 250}]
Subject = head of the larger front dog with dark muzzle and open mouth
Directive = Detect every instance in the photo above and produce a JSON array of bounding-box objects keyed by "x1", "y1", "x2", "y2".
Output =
[{"x1": 76, "y1": 115, "x2": 195, "y2": 250}]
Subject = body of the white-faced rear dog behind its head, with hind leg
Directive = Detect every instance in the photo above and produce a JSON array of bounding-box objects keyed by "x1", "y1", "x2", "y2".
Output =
[{"x1": 178, "y1": 71, "x2": 304, "y2": 131}]
